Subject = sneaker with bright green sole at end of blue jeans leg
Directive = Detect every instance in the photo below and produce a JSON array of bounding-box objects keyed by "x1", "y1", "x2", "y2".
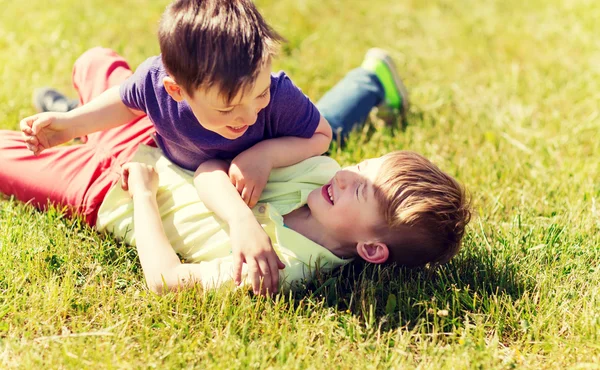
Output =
[{"x1": 361, "y1": 48, "x2": 409, "y2": 117}]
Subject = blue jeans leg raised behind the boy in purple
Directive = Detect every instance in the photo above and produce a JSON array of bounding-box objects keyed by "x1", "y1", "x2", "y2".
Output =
[{"x1": 317, "y1": 68, "x2": 385, "y2": 143}]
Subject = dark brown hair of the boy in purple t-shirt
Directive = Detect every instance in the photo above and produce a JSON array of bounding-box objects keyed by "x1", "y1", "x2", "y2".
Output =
[{"x1": 158, "y1": 0, "x2": 283, "y2": 102}]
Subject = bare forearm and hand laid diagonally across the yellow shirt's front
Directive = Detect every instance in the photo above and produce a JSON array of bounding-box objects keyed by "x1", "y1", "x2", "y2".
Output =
[{"x1": 194, "y1": 159, "x2": 285, "y2": 294}]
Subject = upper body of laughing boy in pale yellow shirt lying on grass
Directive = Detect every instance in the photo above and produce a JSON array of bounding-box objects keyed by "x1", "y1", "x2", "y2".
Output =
[{"x1": 111, "y1": 146, "x2": 470, "y2": 292}]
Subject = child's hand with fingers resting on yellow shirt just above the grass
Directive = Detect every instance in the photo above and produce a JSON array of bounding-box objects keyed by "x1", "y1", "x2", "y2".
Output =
[{"x1": 230, "y1": 217, "x2": 285, "y2": 294}]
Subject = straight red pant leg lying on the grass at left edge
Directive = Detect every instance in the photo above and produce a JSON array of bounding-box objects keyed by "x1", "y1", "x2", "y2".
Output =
[{"x1": 0, "y1": 130, "x2": 119, "y2": 226}]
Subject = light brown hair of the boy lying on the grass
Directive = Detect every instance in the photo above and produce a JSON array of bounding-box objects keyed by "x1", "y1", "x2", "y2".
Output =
[{"x1": 375, "y1": 151, "x2": 471, "y2": 266}]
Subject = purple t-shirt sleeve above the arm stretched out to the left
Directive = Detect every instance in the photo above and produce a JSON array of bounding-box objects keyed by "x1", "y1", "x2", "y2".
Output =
[{"x1": 119, "y1": 57, "x2": 160, "y2": 112}]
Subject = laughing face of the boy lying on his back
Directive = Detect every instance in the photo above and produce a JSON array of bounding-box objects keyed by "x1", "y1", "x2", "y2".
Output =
[{"x1": 307, "y1": 158, "x2": 385, "y2": 244}]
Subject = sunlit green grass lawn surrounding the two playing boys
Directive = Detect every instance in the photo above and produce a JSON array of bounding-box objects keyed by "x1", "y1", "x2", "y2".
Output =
[{"x1": 0, "y1": 0, "x2": 600, "y2": 369}]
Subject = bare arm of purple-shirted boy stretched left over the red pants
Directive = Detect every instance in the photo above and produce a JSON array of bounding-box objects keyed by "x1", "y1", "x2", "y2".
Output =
[{"x1": 20, "y1": 86, "x2": 142, "y2": 155}]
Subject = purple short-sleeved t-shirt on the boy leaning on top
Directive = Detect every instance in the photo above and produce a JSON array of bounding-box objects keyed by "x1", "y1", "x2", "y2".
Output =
[{"x1": 120, "y1": 56, "x2": 321, "y2": 171}]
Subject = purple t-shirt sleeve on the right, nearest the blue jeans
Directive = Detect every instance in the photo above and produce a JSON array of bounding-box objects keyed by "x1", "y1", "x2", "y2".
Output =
[{"x1": 270, "y1": 72, "x2": 321, "y2": 138}]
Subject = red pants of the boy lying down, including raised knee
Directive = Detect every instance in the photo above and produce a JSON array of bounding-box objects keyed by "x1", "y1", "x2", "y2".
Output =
[{"x1": 0, "y1": 48, "x2": 154, "y2": 226}]
